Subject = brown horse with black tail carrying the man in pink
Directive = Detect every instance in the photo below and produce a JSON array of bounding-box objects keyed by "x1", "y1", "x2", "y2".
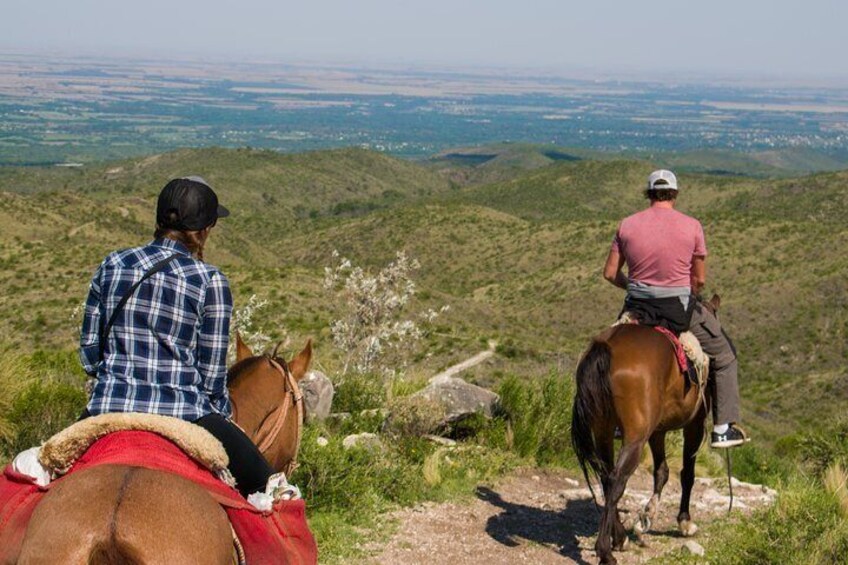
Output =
[{"x1": 571, "y1": 296, "x2": 719, "y2": 563}]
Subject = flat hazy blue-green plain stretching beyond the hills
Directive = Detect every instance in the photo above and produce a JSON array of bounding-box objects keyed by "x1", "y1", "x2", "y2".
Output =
[{"x1": 0, "y1": 54, "x2": 848, "y2": 165}]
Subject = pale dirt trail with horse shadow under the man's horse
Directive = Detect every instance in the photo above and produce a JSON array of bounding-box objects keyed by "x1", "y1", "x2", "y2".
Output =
[{"x1": 369, "y1": 469, "x2": 776, "y2": 565}]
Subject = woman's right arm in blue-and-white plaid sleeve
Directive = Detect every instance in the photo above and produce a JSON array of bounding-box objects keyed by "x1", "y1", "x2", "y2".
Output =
[{"x1": 197, "y1": 273, "x2": 233, "y2": 417}]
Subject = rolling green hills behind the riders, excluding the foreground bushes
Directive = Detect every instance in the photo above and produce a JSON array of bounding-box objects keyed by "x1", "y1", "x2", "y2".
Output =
[{"x1": 0, "y1": 148, "x2": 848, "y2": 436}]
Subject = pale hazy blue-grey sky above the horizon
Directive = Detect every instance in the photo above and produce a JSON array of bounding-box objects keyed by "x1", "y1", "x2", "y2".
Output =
[{"x1": 0, "y1": 0, "x2": 848, "y2": 77}]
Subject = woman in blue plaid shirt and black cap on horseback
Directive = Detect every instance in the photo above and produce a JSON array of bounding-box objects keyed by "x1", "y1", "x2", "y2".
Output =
[{"x1": 80, "y1": 177, "x2": 274, "y2": 496}]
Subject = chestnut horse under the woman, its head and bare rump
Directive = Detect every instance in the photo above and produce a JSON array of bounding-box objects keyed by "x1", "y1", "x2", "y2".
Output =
[{"x1": 18, "y1": 337, "x2": 312, "y2": 565}]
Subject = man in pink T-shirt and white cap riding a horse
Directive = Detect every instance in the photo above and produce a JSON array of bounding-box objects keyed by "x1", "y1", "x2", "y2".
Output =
[{"x1": 604, "y1": 170, "x2": 748, "y2": 448}]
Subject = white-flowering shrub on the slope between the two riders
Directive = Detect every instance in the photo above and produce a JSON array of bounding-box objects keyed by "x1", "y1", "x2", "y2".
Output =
[{"x1": 324, "y1": 251, "x2": 448, "y2": 377}]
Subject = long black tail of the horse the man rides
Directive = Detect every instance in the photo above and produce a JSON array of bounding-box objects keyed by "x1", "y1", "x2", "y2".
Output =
[{"x1": 571, "y1": 339, "x2": 613, "y2": 503}]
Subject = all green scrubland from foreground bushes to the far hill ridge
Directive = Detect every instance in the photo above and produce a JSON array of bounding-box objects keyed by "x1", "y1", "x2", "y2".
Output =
[{"x1": 0, "y1": 144, "x2": 848, "y2": 563}]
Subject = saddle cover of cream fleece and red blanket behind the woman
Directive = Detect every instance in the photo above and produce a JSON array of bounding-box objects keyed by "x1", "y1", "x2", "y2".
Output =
[{"x1": 0, "y1": 414, "x2": 318, "y2": 565}]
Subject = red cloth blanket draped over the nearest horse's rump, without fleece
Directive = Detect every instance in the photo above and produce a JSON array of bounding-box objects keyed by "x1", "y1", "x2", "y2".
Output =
[{"x1": 0, "y1": 431, "x2": 318, "y2": 565}]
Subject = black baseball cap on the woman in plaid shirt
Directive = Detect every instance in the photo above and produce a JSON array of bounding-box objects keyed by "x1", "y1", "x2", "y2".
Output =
[{"x1": 156, "y1": 176, "x2": 230, "y2": 231}]
